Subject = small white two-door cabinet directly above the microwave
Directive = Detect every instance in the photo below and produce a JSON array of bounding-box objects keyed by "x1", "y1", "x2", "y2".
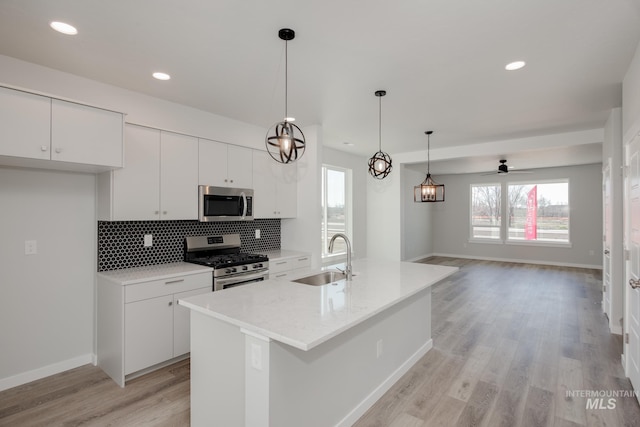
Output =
[{"x1": 198, "y1": 139, "x2": 253, "y2": 188}]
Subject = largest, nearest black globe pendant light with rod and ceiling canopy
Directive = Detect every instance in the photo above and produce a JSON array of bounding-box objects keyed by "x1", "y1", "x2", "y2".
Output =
[{"x1": 265, "y1": 28, "x2": 305, "y2": 163}]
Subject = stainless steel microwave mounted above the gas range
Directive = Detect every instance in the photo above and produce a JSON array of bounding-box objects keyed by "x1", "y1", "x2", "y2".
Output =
[{"x1": 198, "y1": 185, "x2": 253, "y2": 222}]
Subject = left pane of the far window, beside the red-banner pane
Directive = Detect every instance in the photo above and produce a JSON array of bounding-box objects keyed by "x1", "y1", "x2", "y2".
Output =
[{"x1": 471, "y1": 184, "x2": 502, "y2": 240}]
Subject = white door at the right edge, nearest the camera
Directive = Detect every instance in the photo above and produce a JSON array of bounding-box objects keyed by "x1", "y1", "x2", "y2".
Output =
[{"x1": 625, "y1": 134, "x2": 640, "y2": 398}]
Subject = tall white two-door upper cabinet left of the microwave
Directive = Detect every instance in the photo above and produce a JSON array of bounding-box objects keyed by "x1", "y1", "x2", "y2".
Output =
[{"x1": 98, "y1": 124, "x2": 198, "y2": 221}]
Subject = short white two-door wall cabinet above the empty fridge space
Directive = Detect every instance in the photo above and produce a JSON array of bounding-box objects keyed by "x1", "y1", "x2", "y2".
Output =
[{"x1": 0, "y1": 87, "x2": 124, "y2": 172}]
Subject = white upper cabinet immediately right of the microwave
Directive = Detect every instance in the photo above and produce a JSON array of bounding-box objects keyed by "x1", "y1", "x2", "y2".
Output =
[{"x1": 253, "y1": 150, "x2": 298, "y2": 218}]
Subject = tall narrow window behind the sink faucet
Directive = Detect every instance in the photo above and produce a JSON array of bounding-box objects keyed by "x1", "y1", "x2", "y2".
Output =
[{"x1": 321, "y1": 165, "x2": 353, "y2": 258}]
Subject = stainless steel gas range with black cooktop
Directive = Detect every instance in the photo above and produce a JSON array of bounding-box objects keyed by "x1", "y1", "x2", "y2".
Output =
[{"x1": 184, "y1": 234, "x2": 269, "y2": 291}]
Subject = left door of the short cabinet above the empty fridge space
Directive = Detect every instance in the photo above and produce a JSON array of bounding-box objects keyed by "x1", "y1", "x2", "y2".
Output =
[{"x1": 0, "y1": 87, "x2": 51, "y2": 160}]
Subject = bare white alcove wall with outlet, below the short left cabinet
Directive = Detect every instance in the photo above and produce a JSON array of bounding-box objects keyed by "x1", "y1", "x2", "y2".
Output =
[{"x1": 0, "y1": 167, "x2": 96, "y2": 390}]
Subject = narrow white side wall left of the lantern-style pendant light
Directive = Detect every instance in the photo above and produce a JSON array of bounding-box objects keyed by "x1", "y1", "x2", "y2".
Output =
[{"x1": 401, "y1": 165, "x2": 441, "y2": 261}]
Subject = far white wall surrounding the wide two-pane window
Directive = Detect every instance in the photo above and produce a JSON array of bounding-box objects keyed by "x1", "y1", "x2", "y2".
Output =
[{"x1": 433, "y1": 164, "x2": 602, "y2": 268}]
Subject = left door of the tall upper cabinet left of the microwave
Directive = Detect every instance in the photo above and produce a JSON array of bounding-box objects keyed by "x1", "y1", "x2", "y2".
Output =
[{"x1": 111, "y1": 124, "x2": 160, "y2": 221}]
